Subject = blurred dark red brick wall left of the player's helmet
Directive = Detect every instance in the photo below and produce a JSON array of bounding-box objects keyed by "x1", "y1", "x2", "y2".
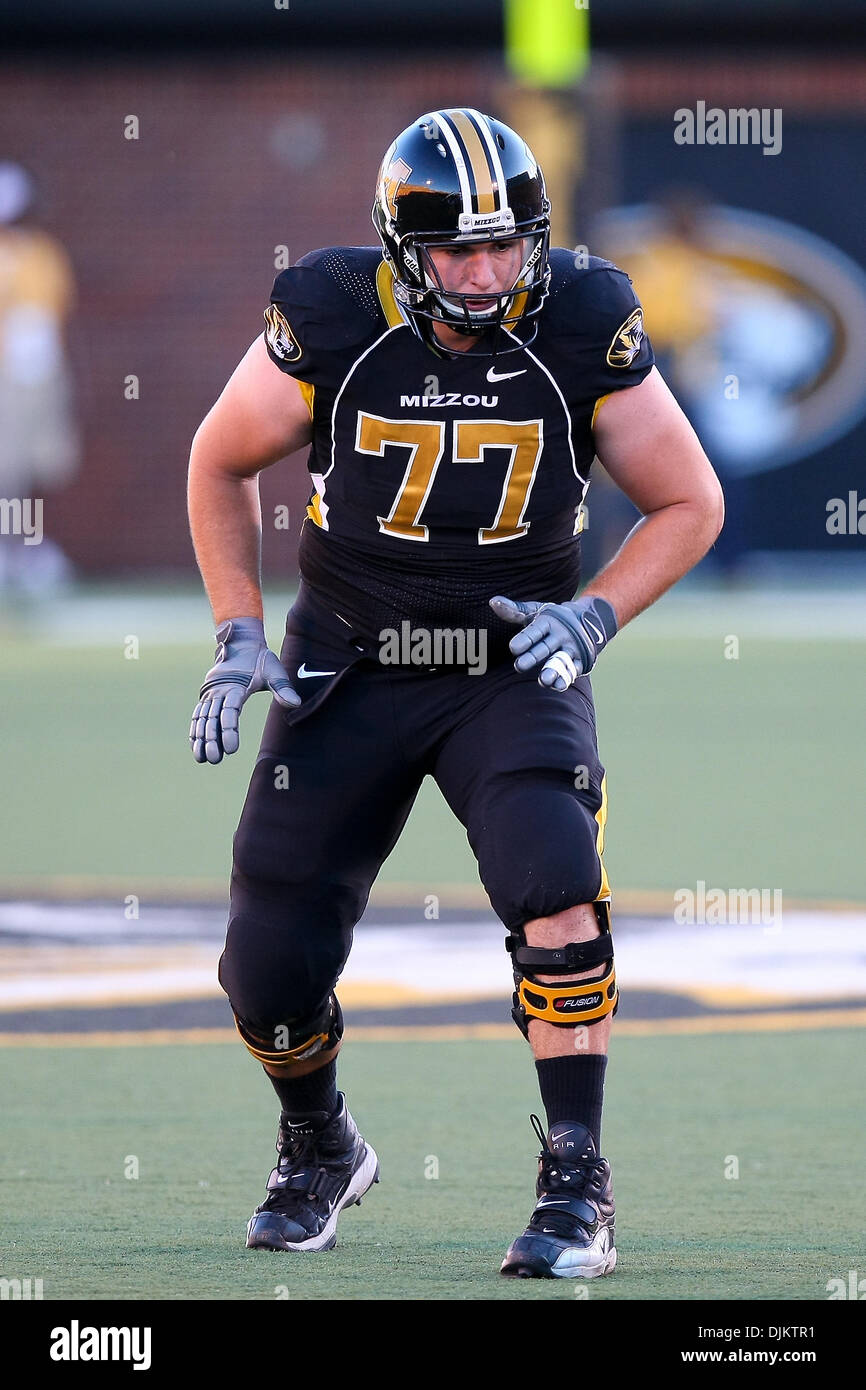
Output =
[{"x1": 0, "y1": 53, "x2": 499, "y2": 577}]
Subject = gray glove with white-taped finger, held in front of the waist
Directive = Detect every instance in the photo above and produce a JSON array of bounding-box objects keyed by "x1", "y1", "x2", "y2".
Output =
[{"x1": 491, "y1": 596, "x2": 617, "y2": 691}]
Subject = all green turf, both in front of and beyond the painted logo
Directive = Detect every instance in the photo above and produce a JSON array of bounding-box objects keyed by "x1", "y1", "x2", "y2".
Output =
[{"x1": 0, "y1": 583, "x2": 866, "y2": 1301}]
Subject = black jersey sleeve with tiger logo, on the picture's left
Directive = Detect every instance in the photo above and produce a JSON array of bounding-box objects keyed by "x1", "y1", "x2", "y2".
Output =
[{"x1": 264, "y1": 250, "x2": 370, "y2": 386}]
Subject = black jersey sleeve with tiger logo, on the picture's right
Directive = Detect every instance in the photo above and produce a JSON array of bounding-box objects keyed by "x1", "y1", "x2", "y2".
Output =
[{"x1": 547, "y1": 261, "x2": 655, "y2": 400}]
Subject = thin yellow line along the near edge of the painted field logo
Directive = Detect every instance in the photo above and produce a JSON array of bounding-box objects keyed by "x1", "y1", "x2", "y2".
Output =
[{"x1": 0, "y1": 1009, "x2": 866, "y2": 1049}]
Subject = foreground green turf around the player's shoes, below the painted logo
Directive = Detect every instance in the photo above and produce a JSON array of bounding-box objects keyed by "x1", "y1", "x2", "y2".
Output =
[{"x1": 0, "y1": 1030, "x2": 865, "y2": 1295}]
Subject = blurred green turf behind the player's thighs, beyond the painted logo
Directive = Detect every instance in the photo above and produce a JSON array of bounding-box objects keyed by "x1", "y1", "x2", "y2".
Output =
[{"x1": 0, "y1": 583, "x2": 866, "y2": 904}]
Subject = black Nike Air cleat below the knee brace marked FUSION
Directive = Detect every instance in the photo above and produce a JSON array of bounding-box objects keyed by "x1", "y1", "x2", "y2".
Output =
[{"x1": 499, "y1": 1115, "x2": 616, "y2": 1279}]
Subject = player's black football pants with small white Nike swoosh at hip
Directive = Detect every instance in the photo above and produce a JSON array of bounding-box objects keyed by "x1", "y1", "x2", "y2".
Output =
[{"x1": 220, "y1": 585, "x2": 607, "y2": 1036}]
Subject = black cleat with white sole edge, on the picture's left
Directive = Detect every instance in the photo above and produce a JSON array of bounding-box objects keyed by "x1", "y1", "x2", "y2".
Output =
[{"x1": 246, "y1": 1091, "x2": 379, "y2": 1250}]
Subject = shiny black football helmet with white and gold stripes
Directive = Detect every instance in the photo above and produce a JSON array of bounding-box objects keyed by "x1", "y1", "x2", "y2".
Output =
[{"x1": 373, "y1": 107, "x2": 550, "y2": 356}]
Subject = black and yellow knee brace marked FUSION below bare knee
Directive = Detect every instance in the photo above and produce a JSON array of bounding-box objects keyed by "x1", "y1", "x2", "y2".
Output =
[{"x1": 505, "y1": 902, "x2": 620, "y2": 1038}]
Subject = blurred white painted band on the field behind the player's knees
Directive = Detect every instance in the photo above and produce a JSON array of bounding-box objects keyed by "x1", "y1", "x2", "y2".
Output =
[{"x1": 0, "y1": 904, "x2": 866, "y2": 1011}]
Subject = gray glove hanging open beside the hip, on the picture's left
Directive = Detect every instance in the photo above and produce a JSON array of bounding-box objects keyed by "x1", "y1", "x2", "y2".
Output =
[{"x1": 189, "y1": 617, "x2": 300, "y2": 763}]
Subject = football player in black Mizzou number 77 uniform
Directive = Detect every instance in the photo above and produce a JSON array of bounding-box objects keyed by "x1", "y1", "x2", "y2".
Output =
[{"x1": 189, "y1": 108, "x2": 723, "y2": 1277}]
